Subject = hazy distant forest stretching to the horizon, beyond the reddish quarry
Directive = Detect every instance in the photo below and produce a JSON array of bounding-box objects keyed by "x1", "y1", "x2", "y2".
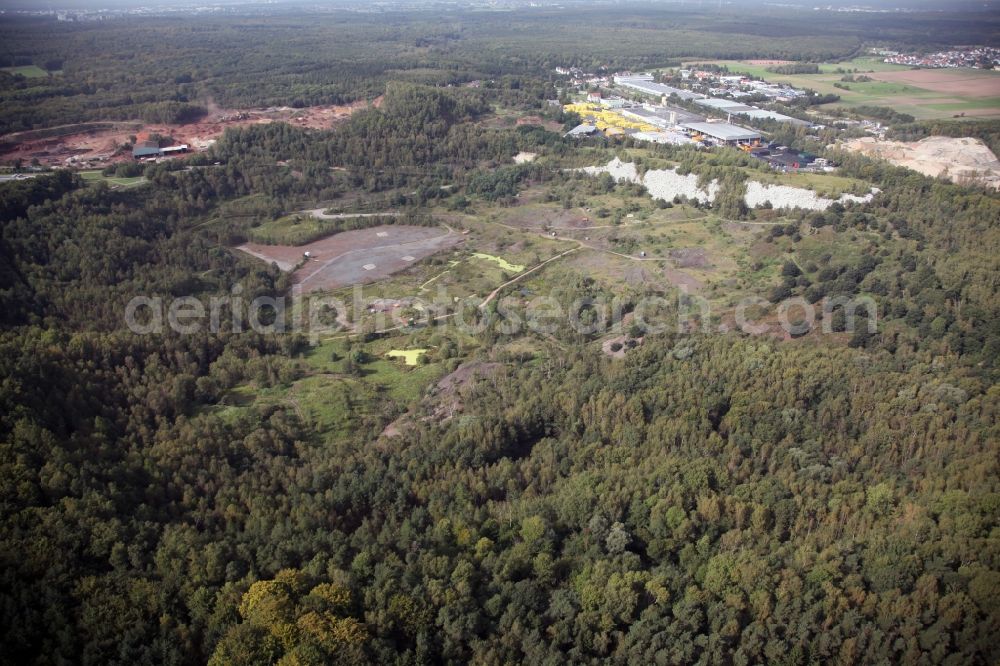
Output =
[{"x1": 0, "y1": 5, "x2": 998, "y2": 134}]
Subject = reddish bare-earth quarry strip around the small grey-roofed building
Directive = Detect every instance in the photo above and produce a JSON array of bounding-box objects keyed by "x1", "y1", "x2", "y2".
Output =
[{"x1": 0, "y1": 98, "x2": 382, "y2": 167}]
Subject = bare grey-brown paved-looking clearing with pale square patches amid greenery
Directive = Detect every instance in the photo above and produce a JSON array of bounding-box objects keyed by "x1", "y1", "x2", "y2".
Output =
[{"x1": 237, "y1": 225, "x2": 462, "y2": 292}]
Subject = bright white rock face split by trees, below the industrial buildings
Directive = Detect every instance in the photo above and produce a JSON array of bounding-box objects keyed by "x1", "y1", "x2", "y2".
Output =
[{"x1": 580, "y1": 157, "x2": 879, "y2": 210}]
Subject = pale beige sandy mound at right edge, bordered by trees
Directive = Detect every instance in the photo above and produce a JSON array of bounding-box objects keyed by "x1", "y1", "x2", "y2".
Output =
[{"x1": 844, "y1": 136, "x2": 1000, "y2": 189}]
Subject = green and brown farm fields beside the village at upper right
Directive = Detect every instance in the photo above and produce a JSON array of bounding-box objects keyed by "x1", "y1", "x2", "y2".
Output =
[{"x1": 692, "y1": 58, "x2": 1000, "y2": 120}]
